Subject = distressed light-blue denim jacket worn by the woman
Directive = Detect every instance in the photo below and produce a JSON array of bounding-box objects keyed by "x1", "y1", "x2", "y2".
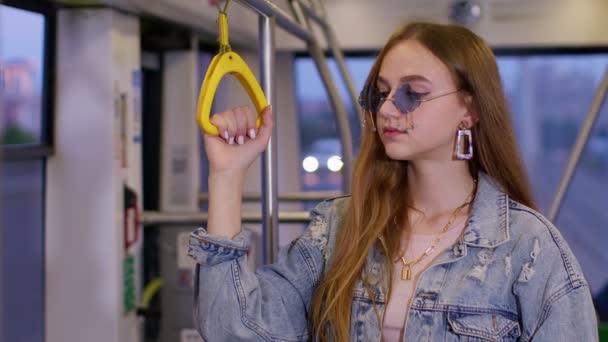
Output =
[{"x1": 189, "y1": 174, "x2": 598, "y2": 342}]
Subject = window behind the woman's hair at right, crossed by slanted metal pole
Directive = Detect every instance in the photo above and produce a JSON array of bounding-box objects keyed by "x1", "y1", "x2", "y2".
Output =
[{"x1": 498, "y1": 54, "x2": 608, "y2": 321}]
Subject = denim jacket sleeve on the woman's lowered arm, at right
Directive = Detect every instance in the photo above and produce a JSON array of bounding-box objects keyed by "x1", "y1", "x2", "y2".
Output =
[{"x1": 516, "y1": 221, "x2": 599, "y2": 342}]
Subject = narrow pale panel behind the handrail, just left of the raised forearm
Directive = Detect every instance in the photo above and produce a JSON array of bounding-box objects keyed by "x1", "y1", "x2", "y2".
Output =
[{"x1": 159, "y1": 45, "x2": 202, "y2": 341}]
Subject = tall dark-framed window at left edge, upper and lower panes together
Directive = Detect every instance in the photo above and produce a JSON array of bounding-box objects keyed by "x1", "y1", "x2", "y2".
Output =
[{"x1": 0, "y1": 0, "x2": 55, "y2": 342}]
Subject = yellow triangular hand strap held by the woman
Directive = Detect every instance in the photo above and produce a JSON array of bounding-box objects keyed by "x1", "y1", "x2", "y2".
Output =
[{"x1": 196, "y1": 0, "x2": 268, "y2": 135}]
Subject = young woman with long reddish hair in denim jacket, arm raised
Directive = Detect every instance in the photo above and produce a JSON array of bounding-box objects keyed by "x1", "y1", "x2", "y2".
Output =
[{"x1": 190, "y1": 23, "x2": 598, "y2": 341}]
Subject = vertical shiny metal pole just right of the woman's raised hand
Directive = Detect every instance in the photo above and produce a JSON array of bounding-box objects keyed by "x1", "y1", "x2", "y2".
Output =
[{"x1": 259, "y1": 15, "x2": 279, "y2": 264}]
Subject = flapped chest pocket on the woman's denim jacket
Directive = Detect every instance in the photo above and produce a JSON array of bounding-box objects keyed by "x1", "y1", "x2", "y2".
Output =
[{"x1": 446, "y1": 312, "x2": 521, "y2": 342}]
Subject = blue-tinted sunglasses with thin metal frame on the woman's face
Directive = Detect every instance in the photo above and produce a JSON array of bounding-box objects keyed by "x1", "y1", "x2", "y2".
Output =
[{"x1": 359, "y1": 83, "x2": 460, "y2": 114}]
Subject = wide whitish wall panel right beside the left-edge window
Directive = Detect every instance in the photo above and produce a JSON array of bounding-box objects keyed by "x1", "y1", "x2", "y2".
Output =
[{"x1": 45, "y1": 9, "x2": 141, "y2": 342}]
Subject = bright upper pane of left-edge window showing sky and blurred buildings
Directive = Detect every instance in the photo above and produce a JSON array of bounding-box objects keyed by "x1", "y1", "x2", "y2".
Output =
[{"x1": 0, "y1": 5, "x2": 46, "y2": 145}]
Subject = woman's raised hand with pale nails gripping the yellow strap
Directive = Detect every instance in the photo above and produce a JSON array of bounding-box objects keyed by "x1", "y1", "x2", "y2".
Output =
[{"x1": 204, "y1": 106, "x2": 273, "y2": 175}]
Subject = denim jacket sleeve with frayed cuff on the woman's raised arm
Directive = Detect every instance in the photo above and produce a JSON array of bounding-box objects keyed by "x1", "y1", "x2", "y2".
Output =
[{"x1": 189, "y1": 201, "x2": 331, "y2": 341}]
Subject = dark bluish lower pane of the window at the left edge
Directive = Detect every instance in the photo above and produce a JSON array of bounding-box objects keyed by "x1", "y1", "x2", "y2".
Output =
[{"x1": 0, "y1": 160, "x2": 44, "y2": 342}]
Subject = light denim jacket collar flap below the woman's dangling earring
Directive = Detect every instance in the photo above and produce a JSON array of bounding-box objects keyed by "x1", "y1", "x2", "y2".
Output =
[{"x1": 462, "y1": 172, "x2": 509, "y2": 248}]
